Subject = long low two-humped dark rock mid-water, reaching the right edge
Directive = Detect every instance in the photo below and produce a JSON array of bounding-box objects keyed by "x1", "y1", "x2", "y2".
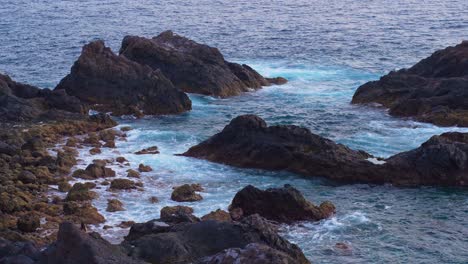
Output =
[{"x1": 183, "y1": 115, "x2": 468, "y2": 187}]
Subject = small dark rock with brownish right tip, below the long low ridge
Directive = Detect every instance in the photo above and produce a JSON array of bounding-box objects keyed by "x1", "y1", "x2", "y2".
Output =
[{"x1": 229, "y1": 185, "x2": 335, "y2": 223}]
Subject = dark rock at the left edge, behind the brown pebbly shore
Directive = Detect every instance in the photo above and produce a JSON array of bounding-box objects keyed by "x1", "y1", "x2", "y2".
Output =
[{"x1": 0, "y1": 74, "x2": 87, "y2": 122}]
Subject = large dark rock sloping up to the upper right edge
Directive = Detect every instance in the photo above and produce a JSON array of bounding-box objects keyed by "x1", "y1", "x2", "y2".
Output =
[{"x1": 352, "y1": 41, "x2": 468, "y2": 126}]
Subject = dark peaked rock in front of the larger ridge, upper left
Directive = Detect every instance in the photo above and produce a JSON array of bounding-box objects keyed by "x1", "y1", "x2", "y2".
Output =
[{"x1": 56, "y1": 41, "x2": 191, "y2": 116}]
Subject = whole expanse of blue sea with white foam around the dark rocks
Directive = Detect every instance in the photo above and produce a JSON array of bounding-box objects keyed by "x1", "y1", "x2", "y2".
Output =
[{"x1": 0, "y1": 0, "x2": 468, "y2": 263}]
